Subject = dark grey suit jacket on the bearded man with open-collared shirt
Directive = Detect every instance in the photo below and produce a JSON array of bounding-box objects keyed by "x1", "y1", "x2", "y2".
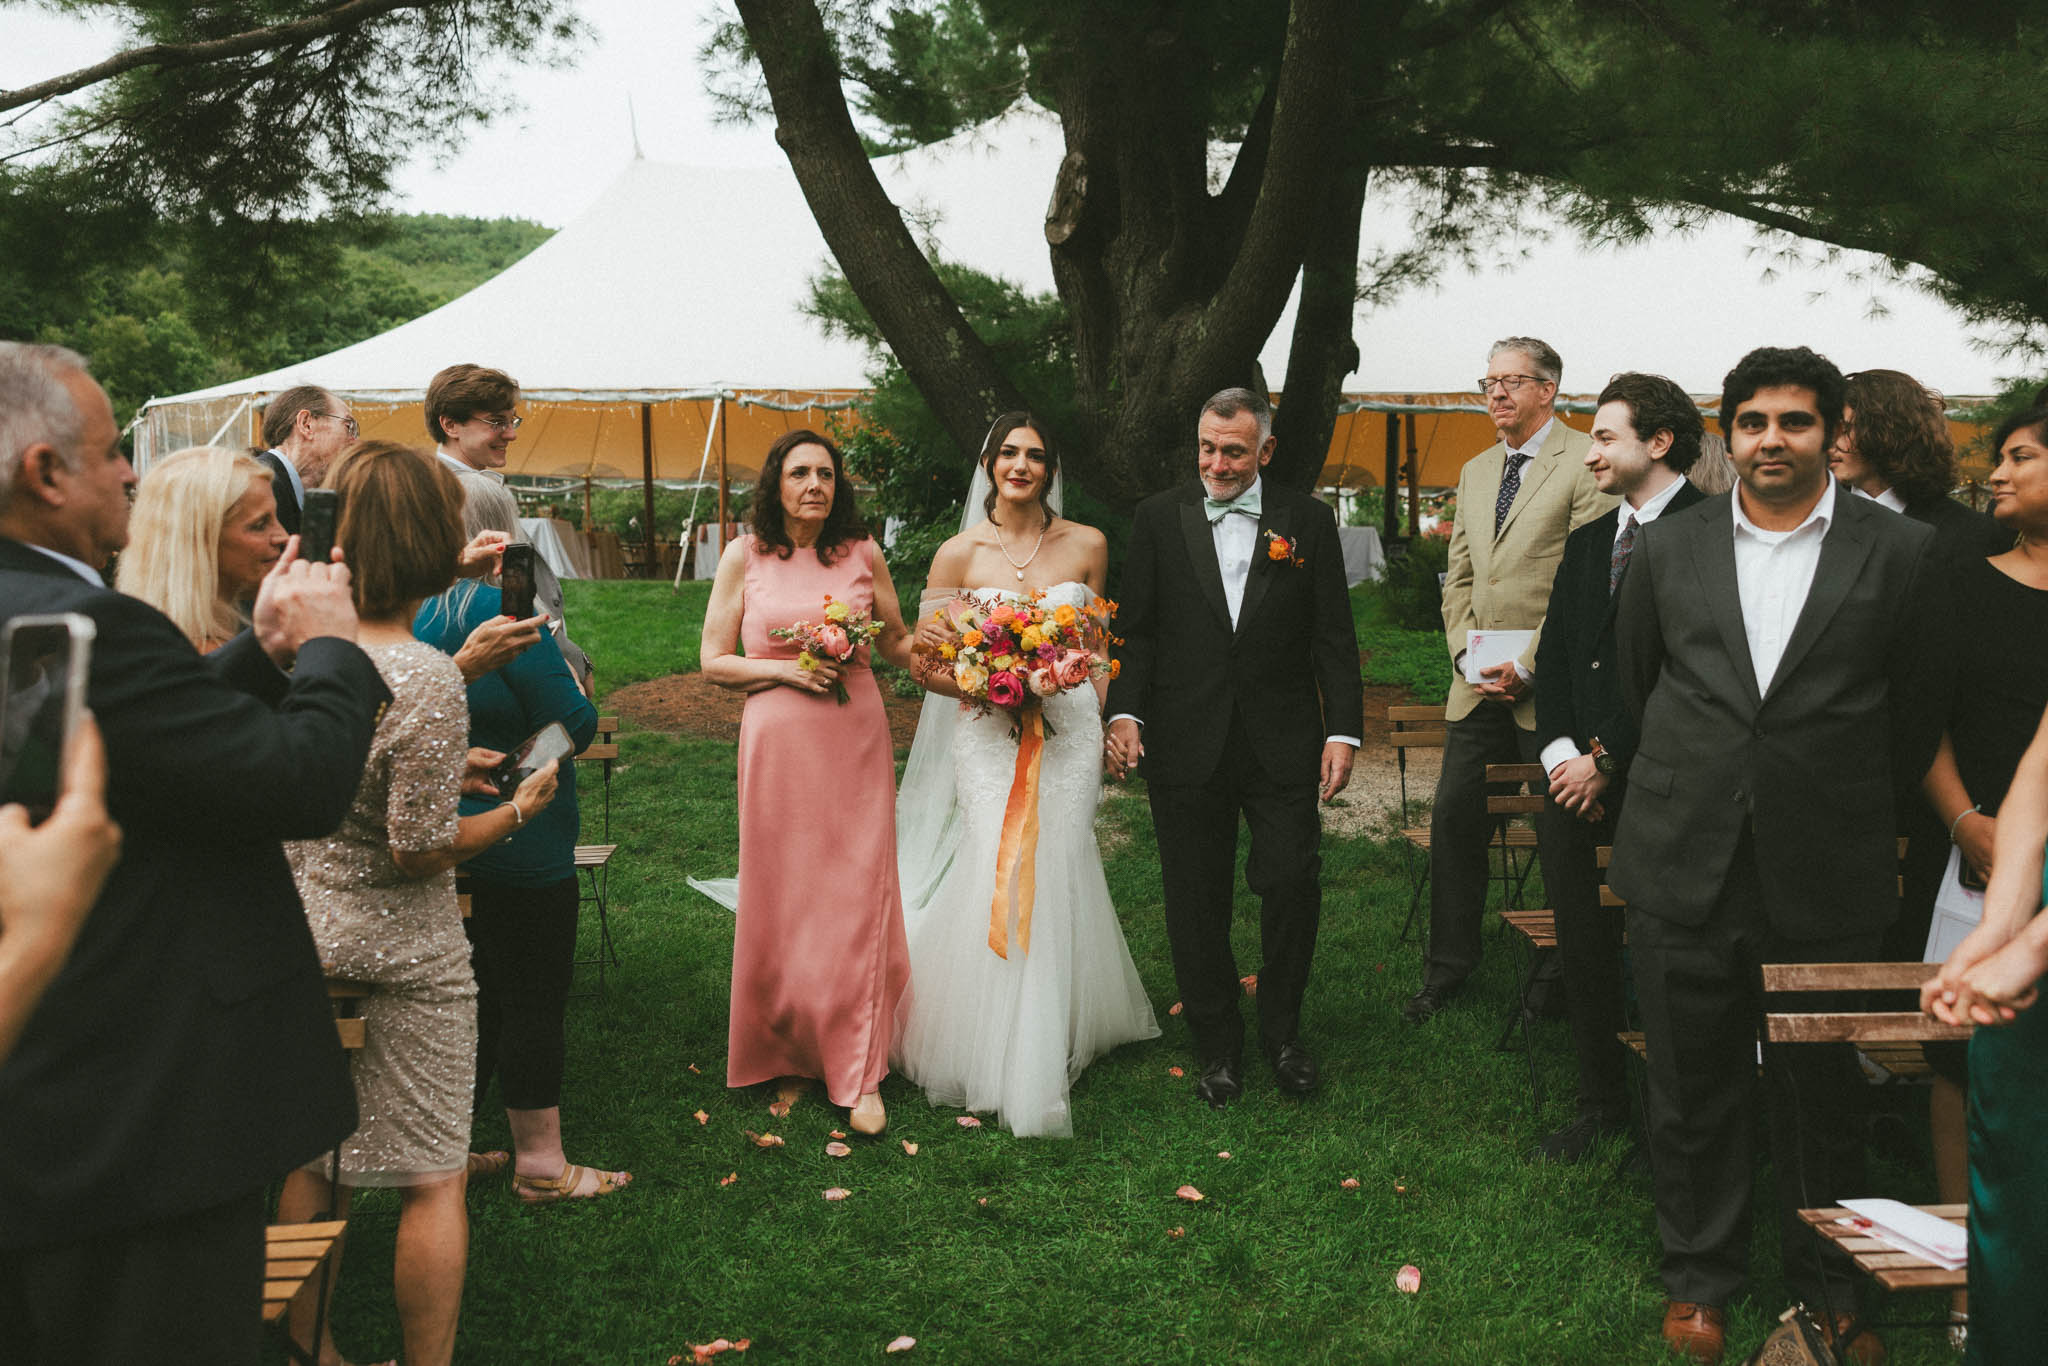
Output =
[{"x1": 1605, "y1": 487, "x2": 1948, "y2": 940}]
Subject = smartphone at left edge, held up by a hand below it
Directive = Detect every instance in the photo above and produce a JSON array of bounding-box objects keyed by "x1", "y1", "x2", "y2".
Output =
[{"x1": 0, "y1": 612, "x2": 94, "y2": 821}]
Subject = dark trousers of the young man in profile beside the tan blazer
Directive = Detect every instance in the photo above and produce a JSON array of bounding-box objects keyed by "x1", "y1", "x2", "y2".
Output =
[{"x1": 1542, "y1": 786, "x2": 1628, "y2": 1128}]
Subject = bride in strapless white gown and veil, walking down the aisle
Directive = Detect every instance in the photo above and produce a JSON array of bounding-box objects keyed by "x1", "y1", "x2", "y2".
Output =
[{"x1": 893, "y1": 414, "x2": 1159, "y2": 1139}]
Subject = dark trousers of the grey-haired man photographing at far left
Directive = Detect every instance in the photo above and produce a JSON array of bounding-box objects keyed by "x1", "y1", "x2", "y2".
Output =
[{"x1": 0, "y1": 1187, "x2": 264, "y2": 1366}]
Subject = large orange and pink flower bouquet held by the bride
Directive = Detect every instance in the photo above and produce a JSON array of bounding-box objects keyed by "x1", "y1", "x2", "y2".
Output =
[{"x1": 913, "y1": 592, "x2": 1116, "y2": 735}]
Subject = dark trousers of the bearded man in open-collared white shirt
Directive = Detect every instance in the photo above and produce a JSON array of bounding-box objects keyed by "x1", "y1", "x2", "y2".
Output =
[{"x1": 1628, "y1": 838, "x2": 1880, "y2": 1313}]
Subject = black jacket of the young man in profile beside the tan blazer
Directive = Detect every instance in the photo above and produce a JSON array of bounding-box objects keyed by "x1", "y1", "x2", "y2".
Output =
[{"x1": 1536, "y1": 481, "x2": 1706, "y2": 774}]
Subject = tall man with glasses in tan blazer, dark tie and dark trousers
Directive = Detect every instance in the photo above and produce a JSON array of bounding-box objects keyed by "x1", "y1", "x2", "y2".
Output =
[{"x1": 1401, "y1": 336, "x2": 1616, "y2": 1024}]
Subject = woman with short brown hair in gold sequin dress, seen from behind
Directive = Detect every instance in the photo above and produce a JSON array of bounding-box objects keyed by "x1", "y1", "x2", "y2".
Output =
[{"x1": 279, "y1": 442, "x2": 555, "y2": 1366}]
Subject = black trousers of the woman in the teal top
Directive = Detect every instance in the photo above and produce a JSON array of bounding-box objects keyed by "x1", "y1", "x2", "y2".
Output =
[{"x1": 465, "y1": 872, "x2": 580, "y2": 1110}]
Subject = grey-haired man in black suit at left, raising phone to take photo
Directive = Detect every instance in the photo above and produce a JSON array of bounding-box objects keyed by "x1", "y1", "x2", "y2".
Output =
[{"x1": 0, "y1": 342, "x2": 391, "y2": 1366}]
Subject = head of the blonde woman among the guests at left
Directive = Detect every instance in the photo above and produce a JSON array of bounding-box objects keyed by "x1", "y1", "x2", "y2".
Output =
[{"x1": 115, "y1": 446, "x2": 289, "y2": 653}]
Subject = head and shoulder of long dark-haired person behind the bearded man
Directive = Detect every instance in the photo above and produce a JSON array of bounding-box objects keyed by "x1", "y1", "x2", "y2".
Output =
[{"x1": 1829, "y1": 371, "x2": 2013, "y2": 559}]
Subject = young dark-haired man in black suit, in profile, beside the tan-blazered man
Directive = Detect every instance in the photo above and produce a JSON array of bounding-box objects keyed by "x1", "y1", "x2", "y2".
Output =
[{"x1": 1532, "y1": 375, "x2": 1706, "y2": 1163}]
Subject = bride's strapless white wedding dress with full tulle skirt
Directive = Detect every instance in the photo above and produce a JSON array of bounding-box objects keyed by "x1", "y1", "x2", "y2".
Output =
[{"x1": 893, "y1": 582, "x2": 1159, "y2": 1139}]
